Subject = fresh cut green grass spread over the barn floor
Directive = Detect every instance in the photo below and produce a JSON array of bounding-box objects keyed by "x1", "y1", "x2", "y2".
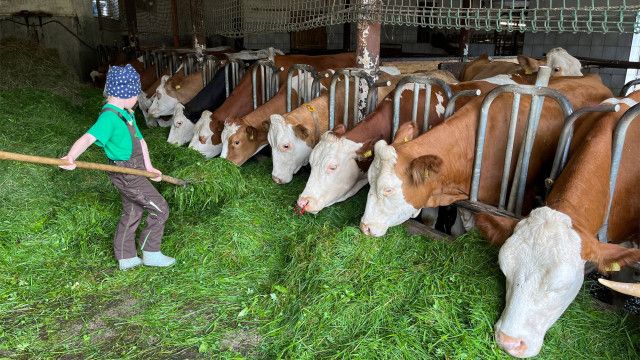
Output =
[{"x1": 0, "y1": 40, "x2": 640, "y2": 359}]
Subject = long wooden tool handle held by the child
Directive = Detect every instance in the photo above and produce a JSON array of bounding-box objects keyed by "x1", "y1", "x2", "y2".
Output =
[{"x1": 0, "y1": 151, "x2": 188, "y2": 186}]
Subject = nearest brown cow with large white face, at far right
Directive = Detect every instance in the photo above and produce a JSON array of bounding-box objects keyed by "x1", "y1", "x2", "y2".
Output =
[{"x1": 476, "y1": 92, "x2": 640, "y2": 358}]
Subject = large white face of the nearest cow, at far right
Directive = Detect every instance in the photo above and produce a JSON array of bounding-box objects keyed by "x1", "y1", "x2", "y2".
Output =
[{"x1": 495, "y1": 207, "x2": 585, "y2": 358}]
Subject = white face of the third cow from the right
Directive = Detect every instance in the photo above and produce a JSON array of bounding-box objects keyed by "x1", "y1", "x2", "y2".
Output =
[{"x1": 298, "y1": 132, "x2": 367, "y2": 214}]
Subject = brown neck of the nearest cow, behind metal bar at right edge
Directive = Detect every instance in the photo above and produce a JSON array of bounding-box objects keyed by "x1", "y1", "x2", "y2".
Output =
[{"x1": 547, "y1": 101, "x2": 640, "y2": 246}]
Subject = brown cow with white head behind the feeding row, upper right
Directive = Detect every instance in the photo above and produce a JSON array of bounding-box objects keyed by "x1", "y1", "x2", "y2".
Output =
[{"x1": 459, "y1": 47, "x2": 582, "y2": 81}]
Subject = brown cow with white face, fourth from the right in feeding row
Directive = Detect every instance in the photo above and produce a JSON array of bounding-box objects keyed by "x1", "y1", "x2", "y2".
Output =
[{"x1": 267, "y1": 68, "x2": 400, "y2": 184}]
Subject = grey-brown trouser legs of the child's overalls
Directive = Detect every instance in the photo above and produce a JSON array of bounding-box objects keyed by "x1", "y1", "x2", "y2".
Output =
[{"x1": 109, "y1": 170, "x2": 169, "y2": 260}]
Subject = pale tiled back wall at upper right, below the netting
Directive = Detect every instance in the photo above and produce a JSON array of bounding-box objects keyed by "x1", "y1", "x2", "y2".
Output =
[{"x1": 523, "y1": 32, "x2": 640, "y2": 94}]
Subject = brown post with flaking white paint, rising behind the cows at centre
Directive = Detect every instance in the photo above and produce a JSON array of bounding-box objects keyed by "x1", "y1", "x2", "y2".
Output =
[{"x1": 354, "y1": 0, "x2": 381, "y2": 121}]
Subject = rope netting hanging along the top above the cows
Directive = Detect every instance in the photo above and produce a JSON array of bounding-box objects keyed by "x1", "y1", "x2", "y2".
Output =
[{"x1": 138, "y1": 0, "x2": 640, "y2": 37}]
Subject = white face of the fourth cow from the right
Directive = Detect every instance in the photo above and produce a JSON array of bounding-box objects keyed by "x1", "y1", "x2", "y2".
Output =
[{"x1": 267, "y1": 114, "x2": 312, "y2": 184}]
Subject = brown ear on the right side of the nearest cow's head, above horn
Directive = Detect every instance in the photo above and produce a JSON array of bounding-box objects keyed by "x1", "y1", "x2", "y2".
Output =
[{"x1": 579, "y1": 231, "x2": 640, "y2": 272}]
